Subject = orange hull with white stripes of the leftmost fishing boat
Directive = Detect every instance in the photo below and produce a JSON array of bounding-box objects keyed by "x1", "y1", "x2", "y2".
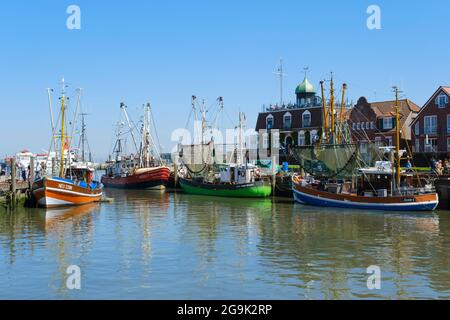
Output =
[{"x1": 32, "y1": 178, "x2": 103, "y2": 208}]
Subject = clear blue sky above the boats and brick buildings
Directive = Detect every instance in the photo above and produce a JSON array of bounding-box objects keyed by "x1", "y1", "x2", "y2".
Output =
[{"x1": 0, "y1": 0, "x2": 450, "y2": 160}]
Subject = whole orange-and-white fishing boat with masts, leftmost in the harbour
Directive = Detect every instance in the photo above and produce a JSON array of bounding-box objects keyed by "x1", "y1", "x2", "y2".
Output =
[{"x1": 32, "y1": 79, "x2": 102, "y2": 208}]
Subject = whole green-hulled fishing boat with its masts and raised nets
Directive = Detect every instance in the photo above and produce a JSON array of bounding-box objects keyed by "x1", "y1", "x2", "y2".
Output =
[{"x1": 179, "y1": 96, "x2": 272, "y2": 198}]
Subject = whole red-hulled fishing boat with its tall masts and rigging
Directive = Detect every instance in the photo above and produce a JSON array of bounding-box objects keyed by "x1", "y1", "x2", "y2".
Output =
[{"x1": 101, "y1": 103, "x2": 170, "y2": 190}]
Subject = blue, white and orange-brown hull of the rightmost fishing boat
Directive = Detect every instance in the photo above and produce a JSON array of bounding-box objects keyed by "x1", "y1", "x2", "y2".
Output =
[{"x1": 293, "y1": 185, "x2": 439, "y2": 211}]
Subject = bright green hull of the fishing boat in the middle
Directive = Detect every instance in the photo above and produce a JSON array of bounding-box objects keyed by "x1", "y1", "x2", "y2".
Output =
[{"x1": 180, "y1": 179, "x2": 272, "y2": 198}]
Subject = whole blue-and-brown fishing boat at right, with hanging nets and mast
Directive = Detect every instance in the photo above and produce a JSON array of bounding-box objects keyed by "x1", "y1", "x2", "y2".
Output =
[{"x1": 293, "y1": 84, "x2": 439, "y2": 211}]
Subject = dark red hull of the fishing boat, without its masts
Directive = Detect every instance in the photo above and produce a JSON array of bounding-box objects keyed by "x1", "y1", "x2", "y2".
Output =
[{"x1": 102, "y1": 167, "x2": 170, "y2": 189}]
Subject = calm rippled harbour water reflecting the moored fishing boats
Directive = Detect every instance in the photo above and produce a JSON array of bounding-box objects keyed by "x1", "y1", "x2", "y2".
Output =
[{"x1": 0, "y1": 190, "x2": 450, "y2": 299}]
